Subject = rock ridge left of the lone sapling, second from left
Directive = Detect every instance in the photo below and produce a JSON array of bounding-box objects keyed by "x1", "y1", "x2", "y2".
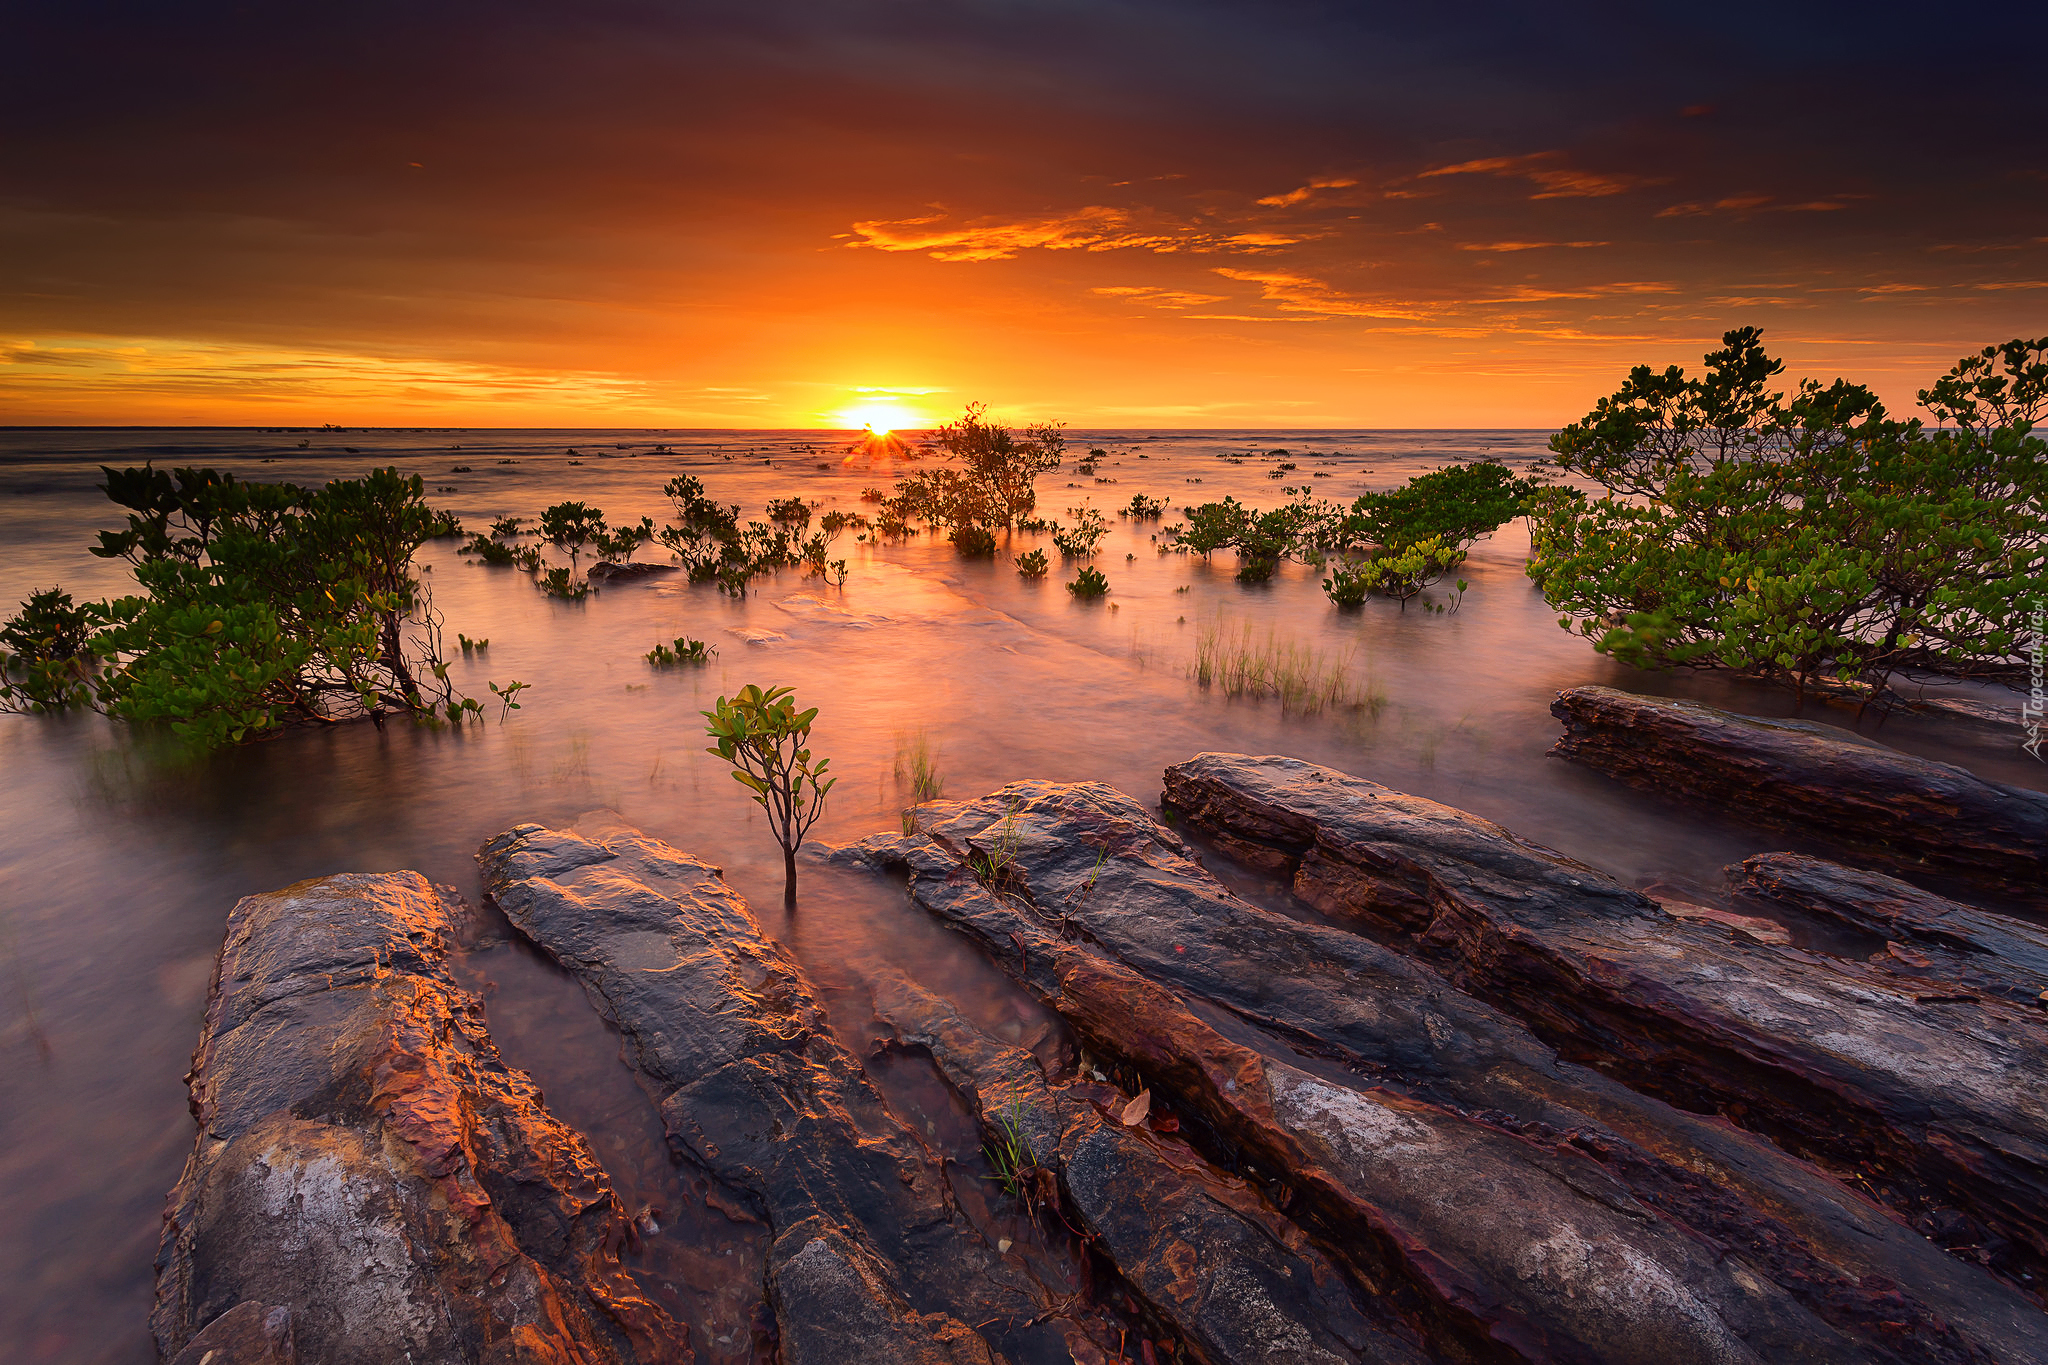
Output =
[{"x1": 477, "y1": 825, "x2": 1092, "y2": 1365}]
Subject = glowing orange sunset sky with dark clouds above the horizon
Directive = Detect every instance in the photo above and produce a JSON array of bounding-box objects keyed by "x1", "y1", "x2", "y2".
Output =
[{"x1": 0, "y1": 4, "x2": 2048, "y2": 428}]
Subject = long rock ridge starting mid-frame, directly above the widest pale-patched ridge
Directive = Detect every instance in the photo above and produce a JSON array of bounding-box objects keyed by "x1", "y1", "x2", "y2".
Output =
[{"x1": 1165, "y1": 753, "x2": 2048, "y2": 1269}]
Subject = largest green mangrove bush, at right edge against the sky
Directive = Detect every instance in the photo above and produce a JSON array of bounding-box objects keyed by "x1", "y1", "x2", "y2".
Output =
[{"x1": 1530, "y1": 327, "x2": 2048, "y2": 698}]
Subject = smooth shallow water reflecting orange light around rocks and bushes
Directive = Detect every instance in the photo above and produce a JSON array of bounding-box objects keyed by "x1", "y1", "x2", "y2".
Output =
[{"x1": 0, "y1": 430, "x2": 2044, "y2": 1365}]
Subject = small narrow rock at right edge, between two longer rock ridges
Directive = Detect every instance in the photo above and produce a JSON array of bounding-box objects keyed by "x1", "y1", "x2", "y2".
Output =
[{"x1": 1729, "y1": 853, "x2": 2048, "y2": 1005}]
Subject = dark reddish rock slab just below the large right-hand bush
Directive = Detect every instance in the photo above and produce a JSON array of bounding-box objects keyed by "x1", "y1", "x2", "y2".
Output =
[{"x1": 1550, "y1": 688, "x2": 2048, "y2": 907}]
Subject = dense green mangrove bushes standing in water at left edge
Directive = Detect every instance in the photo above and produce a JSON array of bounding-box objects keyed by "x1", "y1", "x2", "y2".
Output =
[{"x1": 0, "y1": 465, "x2": 481, "y2": 749}]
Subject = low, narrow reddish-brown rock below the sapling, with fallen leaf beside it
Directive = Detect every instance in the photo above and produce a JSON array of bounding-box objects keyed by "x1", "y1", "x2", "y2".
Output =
[{"x1": 872, "y1": 972, "x2": 1425, "y2": 1365}]
